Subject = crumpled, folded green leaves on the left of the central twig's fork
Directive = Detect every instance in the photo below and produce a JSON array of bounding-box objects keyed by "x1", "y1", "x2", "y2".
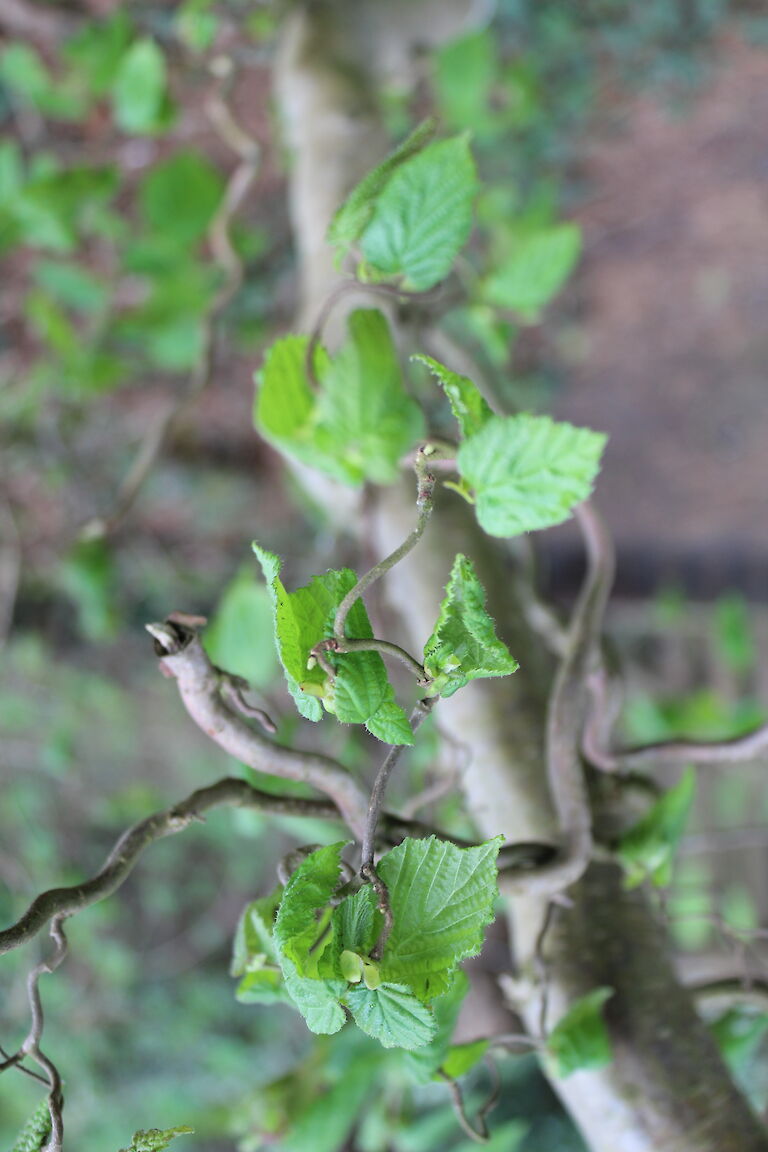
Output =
[{"x1": 253, "y1": 544, "x2": 413, "y2": 744}]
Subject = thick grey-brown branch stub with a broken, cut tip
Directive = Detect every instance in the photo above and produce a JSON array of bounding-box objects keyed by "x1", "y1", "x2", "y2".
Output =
[{"x1": 149, "y1": 619, "x2": 367, "y2": 836}]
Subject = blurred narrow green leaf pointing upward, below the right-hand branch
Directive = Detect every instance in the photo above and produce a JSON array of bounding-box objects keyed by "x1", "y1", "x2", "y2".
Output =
[{"x1": 617, "y1": 768, "x2": 695, "y2": 888}]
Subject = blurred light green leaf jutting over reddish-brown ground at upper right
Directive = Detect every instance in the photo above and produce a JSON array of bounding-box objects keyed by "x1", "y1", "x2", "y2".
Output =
[{"x1": 482, "y1": 223, "x2": 581, "y2": 320}]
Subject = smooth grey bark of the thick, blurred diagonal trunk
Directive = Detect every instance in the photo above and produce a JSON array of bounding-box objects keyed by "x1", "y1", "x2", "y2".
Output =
[{"x1": 272, "y1": 0, "x2": 768, "y2": 1152}]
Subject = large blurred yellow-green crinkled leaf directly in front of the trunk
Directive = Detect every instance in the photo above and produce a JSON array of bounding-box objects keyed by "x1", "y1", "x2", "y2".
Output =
[{"x1": 254, "y1": 309, "x2": 424, "y2": 485}]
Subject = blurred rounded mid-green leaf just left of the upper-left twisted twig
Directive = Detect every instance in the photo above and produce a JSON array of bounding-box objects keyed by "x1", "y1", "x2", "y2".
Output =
[{"x1": 138, "y1": 151, "x2": 223, "y2": 249}]
